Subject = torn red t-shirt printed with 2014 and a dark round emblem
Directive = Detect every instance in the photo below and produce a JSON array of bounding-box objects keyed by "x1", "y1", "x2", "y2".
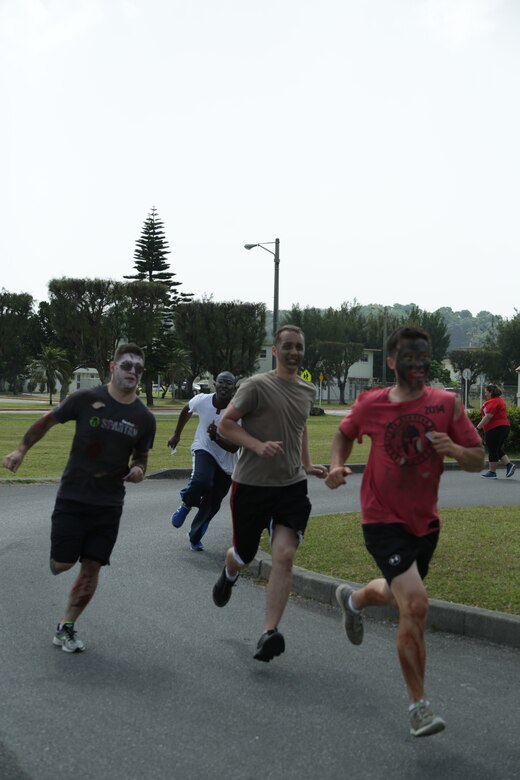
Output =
[{"x1": 340, "y1": 387, "x2": 480, "y2": 536}]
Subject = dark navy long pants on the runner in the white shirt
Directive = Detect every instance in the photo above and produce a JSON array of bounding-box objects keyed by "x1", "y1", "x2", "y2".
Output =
[{"x1": 181, "y1": 450, "x2": 231, "y2": 544}]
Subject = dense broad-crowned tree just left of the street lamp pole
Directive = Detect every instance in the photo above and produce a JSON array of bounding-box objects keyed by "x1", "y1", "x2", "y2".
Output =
[{"x1": 174, "y1": 299, "x2": 265, "y2": 389}]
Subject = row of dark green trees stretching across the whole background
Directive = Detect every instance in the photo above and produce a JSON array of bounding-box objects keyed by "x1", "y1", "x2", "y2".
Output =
[{"x1": 0, "y1": 208, "x2": 520, "y2": 405}]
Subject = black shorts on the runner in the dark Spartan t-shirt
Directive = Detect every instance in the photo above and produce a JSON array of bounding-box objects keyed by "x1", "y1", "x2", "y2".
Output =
[{"x1": 51, "y1": 498, "x2": 123, "y2": 566}]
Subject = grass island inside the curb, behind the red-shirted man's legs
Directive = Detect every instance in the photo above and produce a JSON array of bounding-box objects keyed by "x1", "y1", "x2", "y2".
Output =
[{"x1": 262, "y1": 507, "x2": 520, "y2": 615}]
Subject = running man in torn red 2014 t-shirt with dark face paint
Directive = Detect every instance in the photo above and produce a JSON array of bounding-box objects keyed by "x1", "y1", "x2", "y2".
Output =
[{"x1": 326, "y1": 327, "x2": 484, "y2": 736}]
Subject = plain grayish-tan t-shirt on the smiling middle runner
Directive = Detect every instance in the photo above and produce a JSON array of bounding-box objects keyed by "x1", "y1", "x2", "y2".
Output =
[{"x1": 232, "y1": 371, "x2": 316, "y2": 486}]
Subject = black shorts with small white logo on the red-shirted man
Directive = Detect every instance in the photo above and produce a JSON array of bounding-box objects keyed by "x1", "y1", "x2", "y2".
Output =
[{"x1": 363, "y1": 523, "x2": 439, "y2": 585}]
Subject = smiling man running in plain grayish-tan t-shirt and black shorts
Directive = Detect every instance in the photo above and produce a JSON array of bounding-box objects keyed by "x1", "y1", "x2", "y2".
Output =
[{"x1": 213, "y1": 325, "x2": 327, "y2": 661}]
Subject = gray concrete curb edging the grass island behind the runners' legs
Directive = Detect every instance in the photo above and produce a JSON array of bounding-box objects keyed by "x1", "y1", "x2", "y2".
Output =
[{"x1": 247, "y1": 552, "x2": 520, "y2": 649}]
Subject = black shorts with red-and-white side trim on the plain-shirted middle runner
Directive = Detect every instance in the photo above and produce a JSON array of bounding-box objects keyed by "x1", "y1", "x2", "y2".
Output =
[{"x1": 231, "y1": 479, "x2": 311, "y2": 563}]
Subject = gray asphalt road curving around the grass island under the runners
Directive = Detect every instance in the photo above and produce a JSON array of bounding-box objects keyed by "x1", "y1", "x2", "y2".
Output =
[{"x1": 0, "y1": 472, "x2": 520, "y2": 780}]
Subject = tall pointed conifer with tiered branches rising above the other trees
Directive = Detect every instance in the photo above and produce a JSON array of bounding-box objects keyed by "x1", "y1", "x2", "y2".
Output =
[{"x1": 124, "y1": 207, "x2": 193, "y2": 304}]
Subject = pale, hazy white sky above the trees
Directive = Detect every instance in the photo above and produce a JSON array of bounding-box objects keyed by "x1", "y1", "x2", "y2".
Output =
[{"x1": 0, "y1": 0, "x2": 520, "y2": 317}]
